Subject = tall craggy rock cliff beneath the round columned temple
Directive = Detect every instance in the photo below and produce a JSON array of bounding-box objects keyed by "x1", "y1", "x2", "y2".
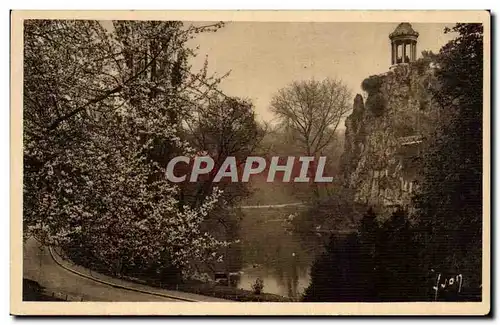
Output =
[{"x1": 342, "y1": 61, "x2": 440, "y2": 211}]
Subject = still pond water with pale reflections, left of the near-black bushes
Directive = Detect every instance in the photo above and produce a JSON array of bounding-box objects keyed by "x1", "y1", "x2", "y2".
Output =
[{"x1": 231, "y1": 209, "x2": 321, "y2": 298}]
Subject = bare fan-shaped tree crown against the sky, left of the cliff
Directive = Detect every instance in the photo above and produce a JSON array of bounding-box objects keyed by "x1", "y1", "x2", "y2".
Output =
[{"x1": 271, "y1": 79, "x2": 351, "y2": 156}]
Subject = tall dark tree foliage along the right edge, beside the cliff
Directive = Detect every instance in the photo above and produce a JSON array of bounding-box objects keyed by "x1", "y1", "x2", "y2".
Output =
[{"x1": 416, "y1": 24, "x2": 483, "y2": 286}]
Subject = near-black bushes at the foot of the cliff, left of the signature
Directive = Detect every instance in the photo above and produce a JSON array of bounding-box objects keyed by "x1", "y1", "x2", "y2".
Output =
[{"x1": 304, "y1": 209, "x2": 432, "y2": 302}]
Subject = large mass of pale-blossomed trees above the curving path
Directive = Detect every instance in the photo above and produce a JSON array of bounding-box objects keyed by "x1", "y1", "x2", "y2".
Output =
[{"x1": 23, "y1": 20, "x2": 236, "y2": 273}]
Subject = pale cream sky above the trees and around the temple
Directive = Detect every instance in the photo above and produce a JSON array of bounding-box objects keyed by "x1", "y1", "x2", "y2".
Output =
[{"x1": 188, "y1": 22, "x2": 454, "y2": 125}]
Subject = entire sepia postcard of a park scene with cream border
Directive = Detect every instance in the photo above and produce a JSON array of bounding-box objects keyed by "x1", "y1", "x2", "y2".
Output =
[{"x1": 10, "y1": 11, "x2": 491, "y2": 315}]
